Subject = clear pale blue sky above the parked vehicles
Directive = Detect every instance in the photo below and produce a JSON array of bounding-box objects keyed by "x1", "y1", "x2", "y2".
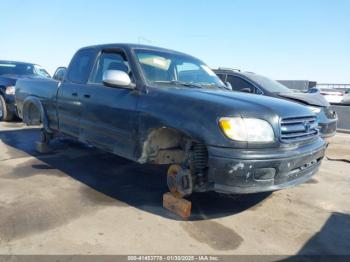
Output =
[{"x1": 0, "y1": 0, "x2": 350, "y2": 83}]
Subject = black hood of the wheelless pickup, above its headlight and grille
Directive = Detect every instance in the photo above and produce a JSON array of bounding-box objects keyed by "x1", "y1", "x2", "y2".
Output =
[{"x1": 159, "y1": 88, "x2": 314, "y2": 119}]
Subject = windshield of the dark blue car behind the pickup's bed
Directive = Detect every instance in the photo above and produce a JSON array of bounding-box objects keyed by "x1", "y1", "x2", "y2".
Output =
[{"x1": 0, "y1": 62, "x2": 50, "y2": 77}]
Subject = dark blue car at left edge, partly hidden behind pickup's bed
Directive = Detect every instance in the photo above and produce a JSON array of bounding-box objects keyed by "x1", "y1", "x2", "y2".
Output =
[{"x1": 0, "y1": 61, "x2": 50, "y2": 121}]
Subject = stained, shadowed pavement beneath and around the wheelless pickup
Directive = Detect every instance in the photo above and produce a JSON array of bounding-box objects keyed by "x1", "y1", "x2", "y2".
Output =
[{"x1": 0, "y1": 123, "x2": 350, "y2": 255}]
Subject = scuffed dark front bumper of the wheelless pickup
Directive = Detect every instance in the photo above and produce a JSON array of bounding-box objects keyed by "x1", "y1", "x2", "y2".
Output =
[{"x1": 208, "y1": 138, "x2": 326, "y2": 194}]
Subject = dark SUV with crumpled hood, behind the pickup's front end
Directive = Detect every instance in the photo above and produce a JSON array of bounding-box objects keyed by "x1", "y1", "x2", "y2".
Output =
[{"x1": 213, "y1": 68, "x2": 338, "y2": 138}]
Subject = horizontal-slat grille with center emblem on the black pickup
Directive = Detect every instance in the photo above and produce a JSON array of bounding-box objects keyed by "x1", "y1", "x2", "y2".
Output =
[{"x1": 281, "y1": 116, "x2": 319, "y2": 143}]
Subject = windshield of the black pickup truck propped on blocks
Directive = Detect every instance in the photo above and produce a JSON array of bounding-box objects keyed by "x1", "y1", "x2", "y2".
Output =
[{"x1": 136, "y1": 50, "x2": 225, "y2": 88}]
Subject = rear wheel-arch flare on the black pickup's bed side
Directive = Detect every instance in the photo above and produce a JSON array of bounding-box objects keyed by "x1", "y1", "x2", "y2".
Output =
[{"x1": 22, "y1": 96, "x2": 52, "y2": 133}]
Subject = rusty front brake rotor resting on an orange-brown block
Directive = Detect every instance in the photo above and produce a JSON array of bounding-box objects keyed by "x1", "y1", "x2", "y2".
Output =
[{"x1": 167, "y1": 165, "x2": 192, "y2": 198}]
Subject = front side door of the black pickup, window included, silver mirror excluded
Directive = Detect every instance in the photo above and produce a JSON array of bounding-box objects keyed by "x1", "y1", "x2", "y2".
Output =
[{"x1": 80, "y1": 49, "x2": 139, "y2": 159}]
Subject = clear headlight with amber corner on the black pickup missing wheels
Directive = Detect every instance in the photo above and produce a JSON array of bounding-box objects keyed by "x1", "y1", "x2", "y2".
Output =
[{"x1": 219, "y1": 117, "x2": 275, "y2": 142}]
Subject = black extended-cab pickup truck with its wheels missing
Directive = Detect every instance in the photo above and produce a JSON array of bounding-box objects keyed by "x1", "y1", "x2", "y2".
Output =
[{"x1": 16, "y1": 44, "x2": 326, "y2": 196}]
